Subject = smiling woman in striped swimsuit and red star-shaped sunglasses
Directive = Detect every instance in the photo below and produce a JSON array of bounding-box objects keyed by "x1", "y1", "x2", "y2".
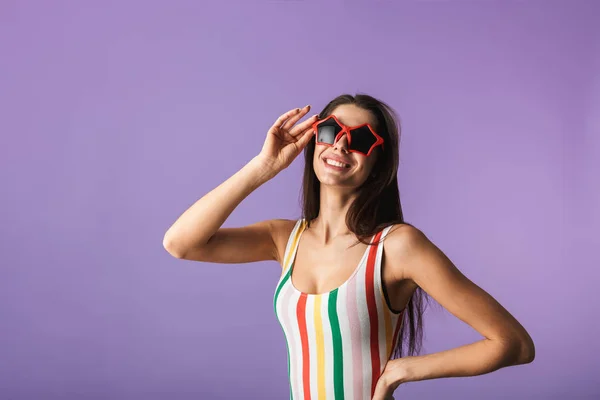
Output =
[{"x1": 163, "y1": 94, "x2": 535, "y2": 400}]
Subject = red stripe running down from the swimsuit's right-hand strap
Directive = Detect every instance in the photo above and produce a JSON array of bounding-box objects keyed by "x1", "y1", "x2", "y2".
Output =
[{"x1": 365, "y1": 232, "x2": 381, "y2": 397}]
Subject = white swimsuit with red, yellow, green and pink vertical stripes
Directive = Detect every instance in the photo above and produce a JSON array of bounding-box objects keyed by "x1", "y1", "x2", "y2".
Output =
[{"x1": 273, "y1": 219, "x2": 402, "y2": 400}]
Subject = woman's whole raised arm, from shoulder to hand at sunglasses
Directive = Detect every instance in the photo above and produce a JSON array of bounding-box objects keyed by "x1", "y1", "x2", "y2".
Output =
[{"x1": 163, "y1": 106, "x2": 315, "y2": 263}]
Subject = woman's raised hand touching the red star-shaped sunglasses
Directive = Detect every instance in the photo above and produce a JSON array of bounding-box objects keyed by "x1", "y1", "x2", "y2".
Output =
[{"x1": 257, "y1": 106, "x2": 317, "y2": 174}]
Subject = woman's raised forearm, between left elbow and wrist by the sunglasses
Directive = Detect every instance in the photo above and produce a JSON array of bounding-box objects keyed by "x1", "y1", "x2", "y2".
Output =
[{"x1": 163, "y1": 157, "x2": 275, "y2": 254}]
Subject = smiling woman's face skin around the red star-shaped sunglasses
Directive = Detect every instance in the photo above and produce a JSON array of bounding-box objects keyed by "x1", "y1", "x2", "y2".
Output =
[{"x1": 313, "y1": 104, "x2": 379, "y2": 187}]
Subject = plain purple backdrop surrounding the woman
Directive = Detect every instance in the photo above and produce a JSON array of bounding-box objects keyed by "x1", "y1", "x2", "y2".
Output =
[{"x1": 0, "y1": 0, "x2": 600, "y2": 400}]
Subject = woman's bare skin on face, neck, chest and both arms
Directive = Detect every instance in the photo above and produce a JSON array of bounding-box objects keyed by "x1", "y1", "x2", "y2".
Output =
[{"x1": 163, "y1": 105, "x2": 535, "y2": 400}]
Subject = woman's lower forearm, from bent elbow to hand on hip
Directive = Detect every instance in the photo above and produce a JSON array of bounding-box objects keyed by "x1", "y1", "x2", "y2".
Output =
[{"x1": 390, "y1": 339, "x2": 526, "y2": 383}]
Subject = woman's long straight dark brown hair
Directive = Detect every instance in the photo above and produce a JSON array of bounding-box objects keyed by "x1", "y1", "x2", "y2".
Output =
[{"x1": 302, "y1": 93, "x2": 428, "y2": 358}]
